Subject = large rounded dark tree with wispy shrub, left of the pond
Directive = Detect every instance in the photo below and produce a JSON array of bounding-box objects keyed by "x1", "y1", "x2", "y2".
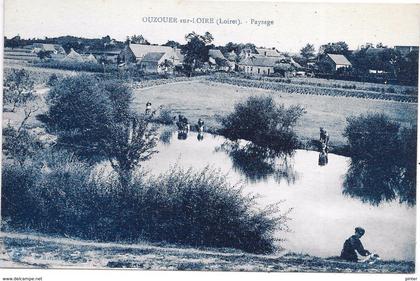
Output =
[{"x1": 45, "y1": 75, "x2": 157, "y2": 188}]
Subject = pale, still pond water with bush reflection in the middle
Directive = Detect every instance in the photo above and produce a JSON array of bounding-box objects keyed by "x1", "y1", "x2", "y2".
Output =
[{"x1": 144, "y1": 131, "x2": 416, "y2": 260}]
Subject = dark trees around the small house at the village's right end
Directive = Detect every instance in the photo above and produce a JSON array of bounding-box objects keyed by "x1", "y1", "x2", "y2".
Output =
[{"x1": 294, "y1": 41, "x2": 419, "y2": 86}]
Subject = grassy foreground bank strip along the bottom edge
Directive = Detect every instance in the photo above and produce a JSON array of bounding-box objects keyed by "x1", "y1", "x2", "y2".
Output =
[{"x1": 0, "y1": 233, "x2": 415, "y2": 273}]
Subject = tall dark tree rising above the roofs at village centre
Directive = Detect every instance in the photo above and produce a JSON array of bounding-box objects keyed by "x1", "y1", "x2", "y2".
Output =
[{"x1": 181, "y1": 32, "x2": 213, "y2": 76}]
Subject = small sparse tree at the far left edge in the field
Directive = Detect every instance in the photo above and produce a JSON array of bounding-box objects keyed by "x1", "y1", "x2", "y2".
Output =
[{"x1": 3, "y1": 69, "x2": 36, "y2": 112}]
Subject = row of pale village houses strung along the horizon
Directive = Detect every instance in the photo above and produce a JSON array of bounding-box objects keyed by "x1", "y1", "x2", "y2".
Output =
[{"x1": 8, "y1": 43, "x2": 418, "y2": 77}]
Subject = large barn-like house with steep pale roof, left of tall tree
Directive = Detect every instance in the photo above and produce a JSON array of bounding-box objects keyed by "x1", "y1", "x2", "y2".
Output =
[{"x1": 118, "y1": 44, "x2": 183, "y2": 73}]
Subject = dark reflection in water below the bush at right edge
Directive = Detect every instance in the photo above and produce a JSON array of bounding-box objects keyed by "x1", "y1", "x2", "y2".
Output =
[{"x1": 343, "y1": 160, "x2": 416, "y2": 206}]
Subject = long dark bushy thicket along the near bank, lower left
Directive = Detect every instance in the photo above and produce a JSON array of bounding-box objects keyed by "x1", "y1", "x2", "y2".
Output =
[{"x1": 1, "y1": 153, "x2": 286, "y2": 253}]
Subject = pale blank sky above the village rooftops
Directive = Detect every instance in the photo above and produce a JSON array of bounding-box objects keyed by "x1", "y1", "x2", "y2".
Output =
[{"x1": 4, "y1": 0, "x2": 420, "y2": 52}]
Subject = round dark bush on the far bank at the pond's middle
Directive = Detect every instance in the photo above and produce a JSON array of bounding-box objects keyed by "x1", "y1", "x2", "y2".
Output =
[{"x1": 220, "y1": 96, "x2": 305, "y2": 153}]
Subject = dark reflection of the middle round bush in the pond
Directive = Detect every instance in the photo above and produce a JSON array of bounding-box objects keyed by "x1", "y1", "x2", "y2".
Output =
[{"x1": 216, "y1": 141, "x2": 298, "y2": 184}]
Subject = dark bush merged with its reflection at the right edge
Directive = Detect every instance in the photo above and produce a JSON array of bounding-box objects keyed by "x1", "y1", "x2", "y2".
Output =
[{"x1": 343, "y1": 114, "x2": 417, "y2": 205}]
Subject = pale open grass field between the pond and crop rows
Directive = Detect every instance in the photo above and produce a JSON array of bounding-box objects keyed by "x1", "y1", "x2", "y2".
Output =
[{"x1": 135, "y1": 81, "x2": 417, "y2": 145}]
